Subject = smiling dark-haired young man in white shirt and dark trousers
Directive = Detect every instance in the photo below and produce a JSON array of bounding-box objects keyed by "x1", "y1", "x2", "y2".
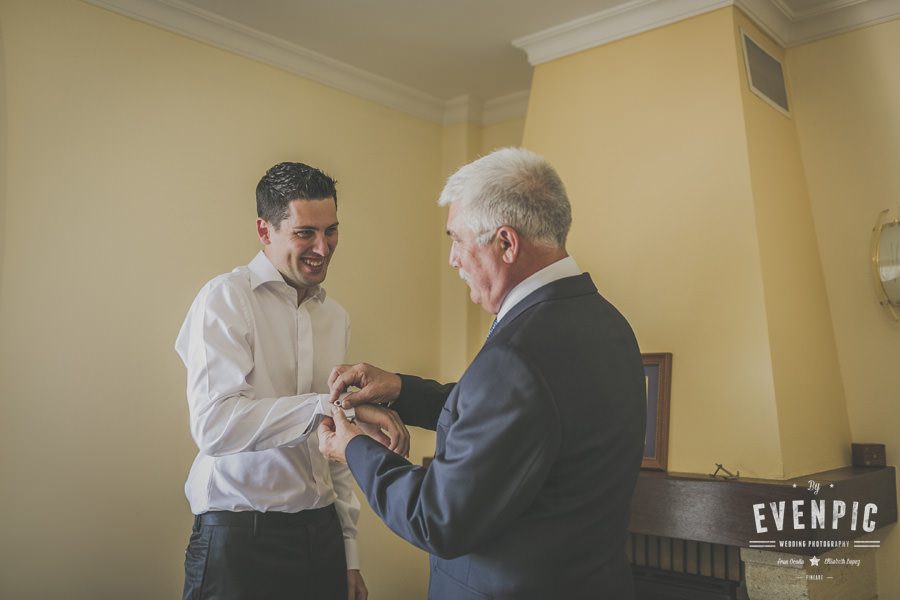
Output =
[{"x1": 176, "y1": 163, "x2": 409, "y2": 600}]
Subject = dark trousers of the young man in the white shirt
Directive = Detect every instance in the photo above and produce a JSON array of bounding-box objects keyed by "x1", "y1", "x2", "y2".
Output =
[{"x1": 184, "y1": 505, "x2": 347, "y2": 600}]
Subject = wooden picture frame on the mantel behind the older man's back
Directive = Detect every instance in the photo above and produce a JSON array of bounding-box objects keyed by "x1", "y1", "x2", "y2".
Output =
[{"x1": 641, "y1": 352, "x2": 672, "y2": 471}]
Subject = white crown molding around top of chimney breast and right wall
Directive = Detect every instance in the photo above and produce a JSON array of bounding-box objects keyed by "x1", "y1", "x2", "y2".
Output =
[{"x1": 512, "y1": 0, "x2": 900, "y2": 65}]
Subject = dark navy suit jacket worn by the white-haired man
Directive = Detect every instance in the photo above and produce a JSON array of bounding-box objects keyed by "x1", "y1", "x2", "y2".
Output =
[{"x1": 346, "y1": 274, "x2": 646, "y2": 600}]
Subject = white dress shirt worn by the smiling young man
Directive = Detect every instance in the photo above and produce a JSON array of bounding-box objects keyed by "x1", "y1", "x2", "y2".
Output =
[{"x1": 175, "y1": 252, "x2": 360, "y2": 569}]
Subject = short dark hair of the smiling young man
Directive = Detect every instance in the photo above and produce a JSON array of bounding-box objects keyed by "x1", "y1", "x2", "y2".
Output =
[{"x1": 256, "y1": 163, "x2": 337, "y2": 230}]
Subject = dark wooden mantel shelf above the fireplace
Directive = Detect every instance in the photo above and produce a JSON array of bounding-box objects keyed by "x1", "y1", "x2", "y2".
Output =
[{"x1": 629, "y1": 467, "x2": 897, "y2": 555}]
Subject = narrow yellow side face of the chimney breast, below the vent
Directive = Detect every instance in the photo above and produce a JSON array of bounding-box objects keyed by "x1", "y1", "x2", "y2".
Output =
[{"x1": 733, "y1": 11, "x2": 850, "y2": 477}]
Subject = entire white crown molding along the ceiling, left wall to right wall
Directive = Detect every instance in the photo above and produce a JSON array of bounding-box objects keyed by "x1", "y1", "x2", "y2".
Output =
[{"x1": 84, "y1": 0, "x2": 900, "y2": 125}]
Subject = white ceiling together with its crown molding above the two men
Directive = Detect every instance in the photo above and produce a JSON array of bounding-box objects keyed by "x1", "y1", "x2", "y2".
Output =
[{"x1": 86, "y1": 0, "x2": 900, "y2": 122}]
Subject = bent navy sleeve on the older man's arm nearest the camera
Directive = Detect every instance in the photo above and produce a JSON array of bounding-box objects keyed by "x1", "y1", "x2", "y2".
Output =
[{"x1": 346, "y1": 347, "x2": 560, "y2": 558}]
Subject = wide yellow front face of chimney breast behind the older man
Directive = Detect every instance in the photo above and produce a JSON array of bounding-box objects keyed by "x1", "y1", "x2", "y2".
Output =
[{"x1": 524, "y1": 9, "x2": 783, "y2": 477}]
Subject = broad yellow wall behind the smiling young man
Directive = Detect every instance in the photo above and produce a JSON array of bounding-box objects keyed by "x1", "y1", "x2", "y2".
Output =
[{"x1": 0, "y1": 0, "x2": 442, "y2": 600}]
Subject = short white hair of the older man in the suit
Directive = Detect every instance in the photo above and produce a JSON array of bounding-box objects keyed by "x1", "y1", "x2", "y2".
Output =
[{"x1": 438, "y1": 148, "x2": 572, "y2": 248}]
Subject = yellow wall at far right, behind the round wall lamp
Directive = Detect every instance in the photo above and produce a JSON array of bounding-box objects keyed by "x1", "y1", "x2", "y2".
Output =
[{"x1": 787, "y1": 21, "x2": 900, "y2": 598}]
